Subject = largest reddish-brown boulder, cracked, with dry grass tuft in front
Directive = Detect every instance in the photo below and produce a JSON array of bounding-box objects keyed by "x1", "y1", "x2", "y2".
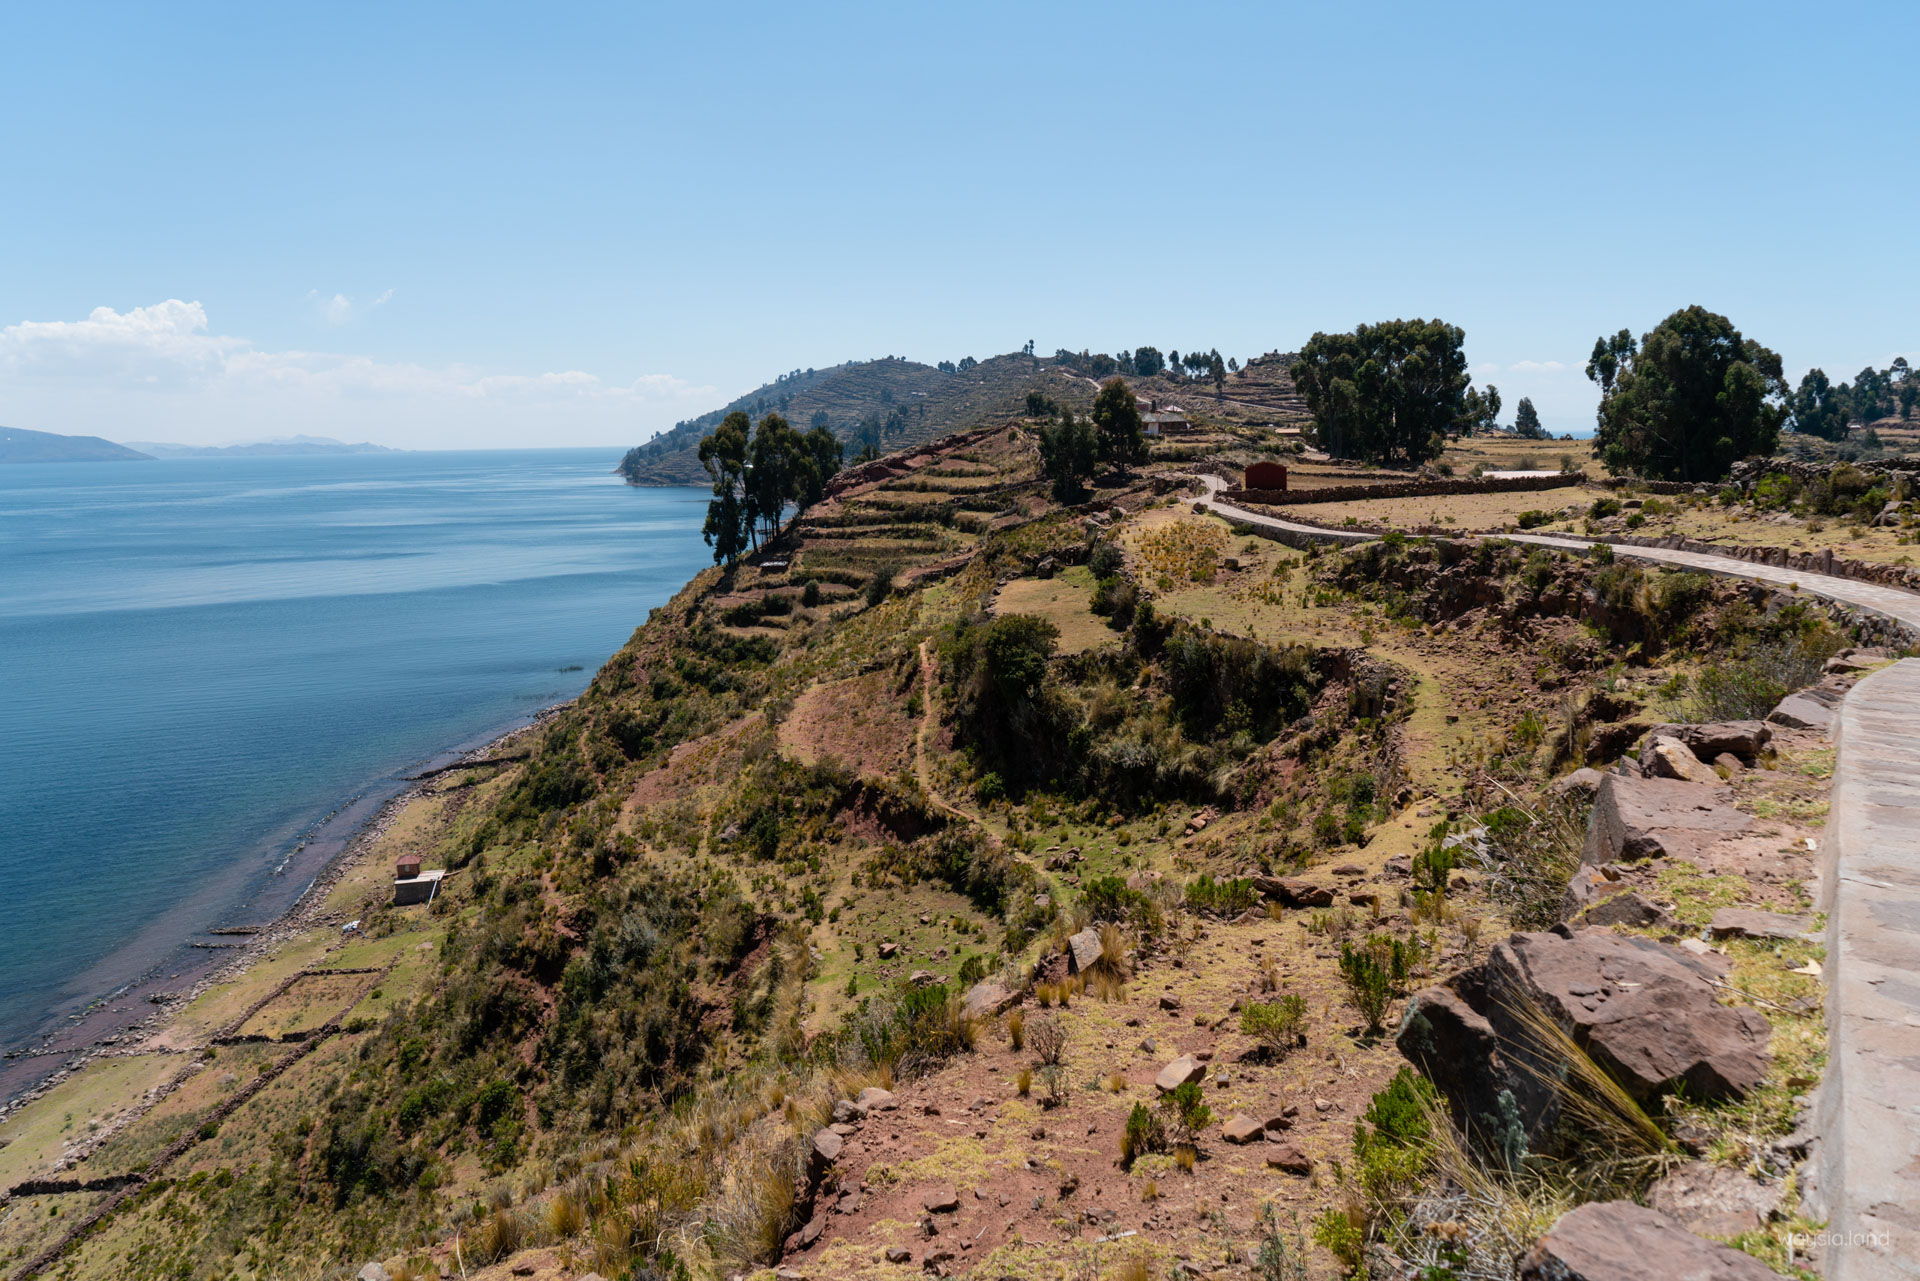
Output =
[{"x1": 1398, "y1": 926, "x2": 1772, "y2": 1154}]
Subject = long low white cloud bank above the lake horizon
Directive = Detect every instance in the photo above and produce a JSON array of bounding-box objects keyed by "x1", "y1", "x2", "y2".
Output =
[{"x1": 0, "y1": 299, "x2": 718, "y2": 446}]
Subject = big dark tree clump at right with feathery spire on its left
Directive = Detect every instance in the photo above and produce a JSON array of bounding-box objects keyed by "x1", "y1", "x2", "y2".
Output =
[{"x1": 1586, "y1": 307, "x2": 1788, "y2": 480}]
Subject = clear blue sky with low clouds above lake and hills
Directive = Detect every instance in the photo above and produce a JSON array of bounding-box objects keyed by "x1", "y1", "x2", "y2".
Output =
[{"x1": 0, "y1": 0, "x2": 1920, "y2": 447}]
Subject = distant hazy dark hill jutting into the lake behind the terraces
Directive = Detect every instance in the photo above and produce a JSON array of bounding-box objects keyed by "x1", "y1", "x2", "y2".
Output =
[{"x1": 618, "y1": 353, "x2": 1096, "y2": 484}]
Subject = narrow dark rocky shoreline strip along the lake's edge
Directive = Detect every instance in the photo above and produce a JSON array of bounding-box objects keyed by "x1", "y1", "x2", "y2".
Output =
[{"x1": 0, "y1": 695, "x2": 580, "y2": 1113}]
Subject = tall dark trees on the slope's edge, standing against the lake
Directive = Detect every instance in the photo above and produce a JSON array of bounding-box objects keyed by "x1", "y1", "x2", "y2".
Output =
[{"x1": 701, "y1": 409, "x2": 845, "y2": 565}]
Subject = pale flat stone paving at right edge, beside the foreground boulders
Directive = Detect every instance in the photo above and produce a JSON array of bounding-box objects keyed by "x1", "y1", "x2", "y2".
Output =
[{"x1": 1809, "y1": 659, "x2": 1920, "y2": 1281}]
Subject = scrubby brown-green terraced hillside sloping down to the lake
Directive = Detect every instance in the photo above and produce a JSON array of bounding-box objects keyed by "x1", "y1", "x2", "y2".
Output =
[{"x1": 0, "y1": 412, "x2": 1847, "y2": 1281}]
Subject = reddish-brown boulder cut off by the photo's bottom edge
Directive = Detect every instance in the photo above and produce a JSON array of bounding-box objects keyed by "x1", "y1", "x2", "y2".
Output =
[{"x1": 1521, "y1": 1200, "x2": 1776, "y2": 1281}]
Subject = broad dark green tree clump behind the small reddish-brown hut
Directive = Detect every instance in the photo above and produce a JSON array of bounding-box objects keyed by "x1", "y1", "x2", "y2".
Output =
[{"x1": 1290, "y1": 321, "x2": 1466, "y2": 465}]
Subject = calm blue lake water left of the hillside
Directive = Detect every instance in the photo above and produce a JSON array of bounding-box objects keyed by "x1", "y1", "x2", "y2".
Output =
[{"x1": 0, "y1": 449, "x2": 710, "y2": 1060}]
